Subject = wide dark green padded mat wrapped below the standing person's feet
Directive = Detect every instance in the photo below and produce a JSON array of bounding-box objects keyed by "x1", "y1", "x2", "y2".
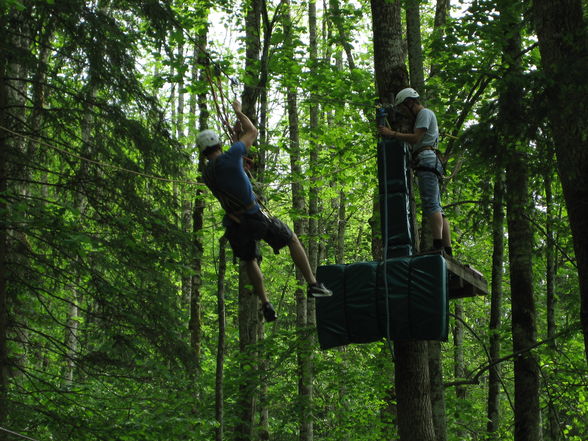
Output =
[{"x1": 316, "y1": 255, "x2": 448, "y2": 349}]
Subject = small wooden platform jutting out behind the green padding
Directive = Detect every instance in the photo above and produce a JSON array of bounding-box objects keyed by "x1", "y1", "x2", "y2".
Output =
[{"x1": 418, "y1": 250, "x2": 488, "y2": 300}]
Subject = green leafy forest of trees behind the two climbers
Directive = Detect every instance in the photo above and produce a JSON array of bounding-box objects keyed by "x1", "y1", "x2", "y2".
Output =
[{"x1": 0, "y1": 0, "x2": 588, "y2": 441}]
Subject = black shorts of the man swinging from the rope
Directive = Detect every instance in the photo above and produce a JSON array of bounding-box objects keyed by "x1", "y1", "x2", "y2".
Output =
[{"x1": 226, "y1": 211, "x2": 294, "y2": 260}]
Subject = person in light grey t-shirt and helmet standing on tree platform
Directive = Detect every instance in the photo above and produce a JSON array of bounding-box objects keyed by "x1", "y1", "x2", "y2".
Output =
[{"x1": 378, "y1": 87, "x2": 452, "y2": 255}]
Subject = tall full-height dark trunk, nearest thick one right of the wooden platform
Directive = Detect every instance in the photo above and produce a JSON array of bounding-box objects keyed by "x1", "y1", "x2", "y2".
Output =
[{"x1": 498, "y1": 0, "x2": 541, "y2": 441}]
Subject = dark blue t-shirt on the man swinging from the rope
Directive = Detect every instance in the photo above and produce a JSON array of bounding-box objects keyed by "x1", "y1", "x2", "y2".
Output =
[{"x1": 205, "y1": 141, "x2": 259, "y2": 213}]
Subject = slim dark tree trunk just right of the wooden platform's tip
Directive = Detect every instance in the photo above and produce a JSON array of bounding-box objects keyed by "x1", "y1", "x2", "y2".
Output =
[{"x1": 486, "y1": 169, "x2": 505, "y2": 434}]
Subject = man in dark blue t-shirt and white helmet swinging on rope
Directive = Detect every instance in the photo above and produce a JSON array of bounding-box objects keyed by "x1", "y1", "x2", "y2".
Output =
[{"x1": 196, "y1": 101, "x2": 333, "y2": 322}]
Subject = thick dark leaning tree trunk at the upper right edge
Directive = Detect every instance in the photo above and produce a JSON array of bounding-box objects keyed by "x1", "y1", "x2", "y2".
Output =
[{"x1": 533, "y1": 0, "x2": 588, "y2": 362}]
